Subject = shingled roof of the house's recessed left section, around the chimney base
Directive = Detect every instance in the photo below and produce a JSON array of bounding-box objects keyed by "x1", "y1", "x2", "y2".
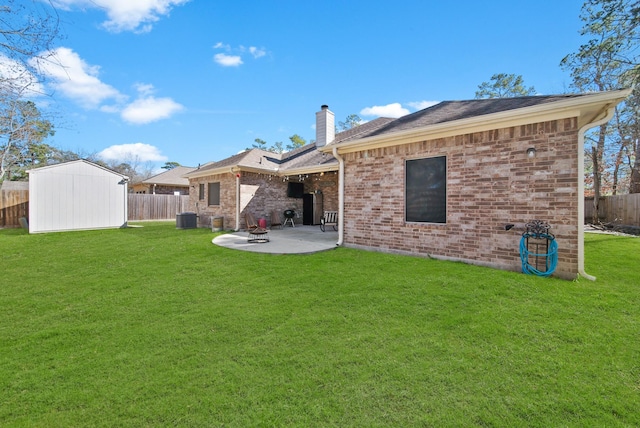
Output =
[{"x1": 185, "y1": 117, "x2": 393, "y2": 178}]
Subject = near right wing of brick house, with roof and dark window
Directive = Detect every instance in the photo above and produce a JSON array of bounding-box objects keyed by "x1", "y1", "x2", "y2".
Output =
[{"x1": 320, "y1": 90, "x2": 630, "y2": 279}]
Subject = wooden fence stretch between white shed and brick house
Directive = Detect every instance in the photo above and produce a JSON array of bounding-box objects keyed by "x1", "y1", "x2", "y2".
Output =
[{"x1": 128, "y1": 194, "x2": 189, "y2": 221}]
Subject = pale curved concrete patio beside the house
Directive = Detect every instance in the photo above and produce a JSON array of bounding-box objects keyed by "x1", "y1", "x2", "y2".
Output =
[{"x1": 212, "y1": 225, "x2": 338, "y2": 254}]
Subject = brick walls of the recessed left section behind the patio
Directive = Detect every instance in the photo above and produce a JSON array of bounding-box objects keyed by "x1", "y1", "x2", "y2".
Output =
[{"x1": 189, "y1": 172, "x2": 338, "y2": 229}]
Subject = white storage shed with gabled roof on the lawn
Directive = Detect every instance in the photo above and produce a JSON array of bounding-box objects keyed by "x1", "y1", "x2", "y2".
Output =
[{"x1": 28, "y1": 160, "x2": 128, "y2": 233}]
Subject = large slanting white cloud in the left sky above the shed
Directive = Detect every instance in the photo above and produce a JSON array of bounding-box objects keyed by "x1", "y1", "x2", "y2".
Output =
[{"x1": 32, "y1": 47, "x2": 126, "y2": 108}]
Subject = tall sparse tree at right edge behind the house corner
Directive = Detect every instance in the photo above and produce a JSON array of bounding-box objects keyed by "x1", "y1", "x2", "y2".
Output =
[{"x1": 560, "y1": 0, "x2": 640, "y2": 204}]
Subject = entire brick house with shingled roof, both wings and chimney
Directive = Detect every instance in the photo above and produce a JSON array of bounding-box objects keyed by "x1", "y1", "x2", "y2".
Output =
[{"x1": 187, "y1": 90, "x2": 630, "y2": 279}]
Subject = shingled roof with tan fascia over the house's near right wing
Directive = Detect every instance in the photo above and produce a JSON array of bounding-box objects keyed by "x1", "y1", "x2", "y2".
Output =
[{"x1": 321, "y1": 89, "x2": 629, "y2": 153}]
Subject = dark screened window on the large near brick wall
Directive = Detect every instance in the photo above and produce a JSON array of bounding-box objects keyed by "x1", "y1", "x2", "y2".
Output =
[{"x1": 405, "y1": 156, "x2": 447, "y2": 223}]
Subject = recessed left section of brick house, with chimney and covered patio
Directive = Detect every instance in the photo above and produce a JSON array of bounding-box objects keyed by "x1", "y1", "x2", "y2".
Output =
[{"x1": 184, "y1": 112, "x2": 393, "y2": 230}]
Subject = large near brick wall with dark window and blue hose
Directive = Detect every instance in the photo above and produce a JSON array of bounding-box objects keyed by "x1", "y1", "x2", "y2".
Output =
[{"x1": 344, "y1": 118, "x2": 582, "y2": 278}]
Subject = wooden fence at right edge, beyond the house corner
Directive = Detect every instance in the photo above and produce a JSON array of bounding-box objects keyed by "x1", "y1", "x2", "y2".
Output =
[{"x1": 584, "y1": 193, "x2": 640, "y2": 227}]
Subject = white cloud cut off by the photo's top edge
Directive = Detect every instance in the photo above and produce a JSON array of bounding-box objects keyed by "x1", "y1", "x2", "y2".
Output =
[{"x1": 53, "y1": 0, "x2": 189, "y2": 33}]
